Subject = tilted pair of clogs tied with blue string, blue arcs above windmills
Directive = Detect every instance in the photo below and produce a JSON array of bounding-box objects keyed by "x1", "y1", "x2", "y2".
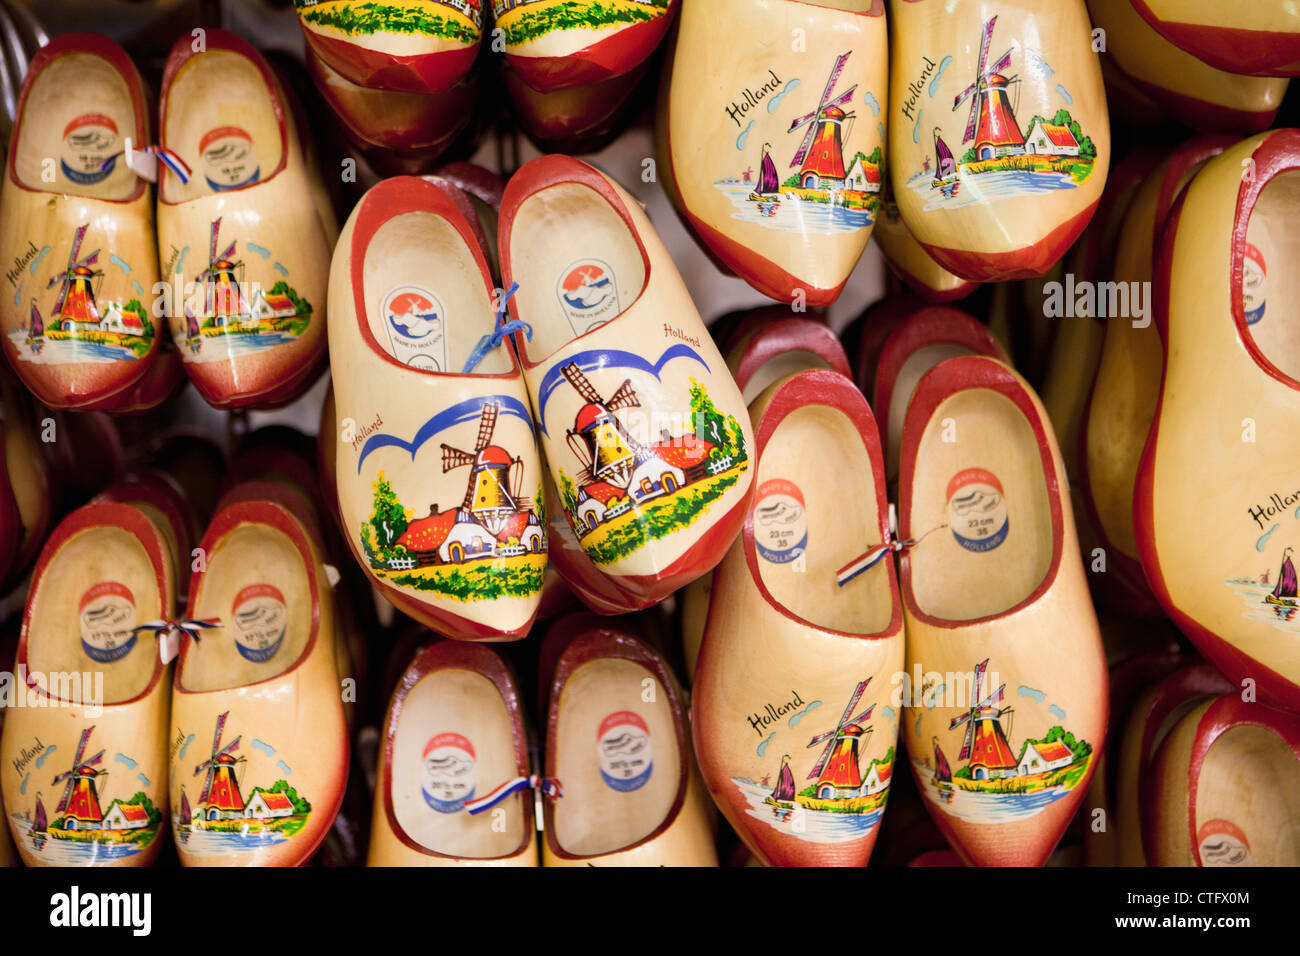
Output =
[{"x1": 329, "y1": 156, "x2": 753, "y2": 640}]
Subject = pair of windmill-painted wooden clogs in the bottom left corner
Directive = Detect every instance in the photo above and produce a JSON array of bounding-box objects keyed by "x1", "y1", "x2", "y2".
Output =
[{"x1": 0, "y1": 494, "x2": 348, "y2": 866}]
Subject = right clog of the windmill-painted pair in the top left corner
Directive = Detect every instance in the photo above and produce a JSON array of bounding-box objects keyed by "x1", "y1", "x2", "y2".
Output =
[{"x1": 157, "y1": 30, "x2": 330, "y2": 408}]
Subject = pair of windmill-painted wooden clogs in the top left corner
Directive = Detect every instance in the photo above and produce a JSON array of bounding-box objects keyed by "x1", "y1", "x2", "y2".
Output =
[{"x1": 0, "y1": 30, "x2": 334, "y2": 411}]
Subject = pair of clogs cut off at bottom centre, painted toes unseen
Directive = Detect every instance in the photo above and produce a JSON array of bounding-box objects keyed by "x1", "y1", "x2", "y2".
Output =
[{"x1": 369, "y1": 615, "x2": 718, "y2": 866}]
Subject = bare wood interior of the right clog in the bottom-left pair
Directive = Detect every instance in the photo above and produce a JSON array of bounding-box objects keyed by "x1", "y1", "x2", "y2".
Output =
[{"x1": 181, "y1": 523, "x2": 312, "y2": 692}]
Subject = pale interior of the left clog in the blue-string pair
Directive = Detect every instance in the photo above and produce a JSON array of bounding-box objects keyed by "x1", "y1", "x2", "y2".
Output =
[{"x1": 363, "y1": 212, "x2": 511, "y2": 375}]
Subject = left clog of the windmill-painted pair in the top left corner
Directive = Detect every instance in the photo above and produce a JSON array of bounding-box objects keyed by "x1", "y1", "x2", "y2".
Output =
[{"x1": 0, "y1": 33, "x2": 165, "y2": 408}]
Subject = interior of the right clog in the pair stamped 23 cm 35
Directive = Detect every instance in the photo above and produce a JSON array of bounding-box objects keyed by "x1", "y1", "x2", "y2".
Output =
[{"x1": 910, "y1": 389, "x2": 1052, "y2": 620}]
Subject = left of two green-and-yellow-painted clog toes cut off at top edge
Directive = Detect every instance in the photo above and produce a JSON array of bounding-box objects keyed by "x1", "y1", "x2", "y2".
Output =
[{"x1": 295, "y1": 0, "x2": 486, "y2": 94}]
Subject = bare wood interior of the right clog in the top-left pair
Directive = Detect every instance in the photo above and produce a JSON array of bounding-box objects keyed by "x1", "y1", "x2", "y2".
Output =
[{"x1": 161, "y1": 49, "x2": 287, "y2": 203}]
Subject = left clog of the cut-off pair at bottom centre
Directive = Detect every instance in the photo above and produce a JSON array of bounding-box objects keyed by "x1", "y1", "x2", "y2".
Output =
[{"x1": 368, "y1": 641, "x2": 538, "y2": 866}]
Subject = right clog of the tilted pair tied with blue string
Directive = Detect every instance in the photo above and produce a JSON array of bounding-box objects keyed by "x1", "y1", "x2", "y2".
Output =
[{"x1": 501, "y1": 156, "x2": 753, "y2": 602}]
